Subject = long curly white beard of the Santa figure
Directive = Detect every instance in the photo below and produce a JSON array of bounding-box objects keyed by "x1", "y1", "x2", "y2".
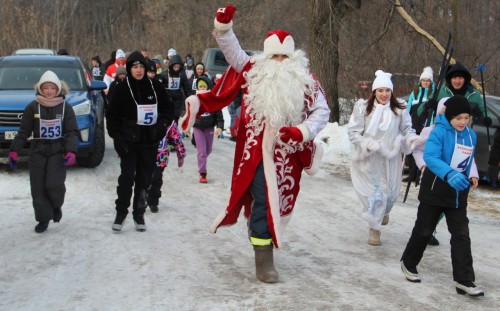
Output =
[{"x1": 244, "y1": 50, "x2": 315, "y2": 134}]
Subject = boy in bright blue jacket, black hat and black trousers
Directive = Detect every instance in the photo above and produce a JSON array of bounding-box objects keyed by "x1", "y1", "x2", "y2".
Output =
[{"x1": 401, "y1": 95, "x2": 484, "y2": 297}]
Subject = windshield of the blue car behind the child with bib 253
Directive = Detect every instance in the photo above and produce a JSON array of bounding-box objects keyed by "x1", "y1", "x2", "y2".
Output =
[{"x1": 0, "y1": 61, "x2": 87, "y2": 91}]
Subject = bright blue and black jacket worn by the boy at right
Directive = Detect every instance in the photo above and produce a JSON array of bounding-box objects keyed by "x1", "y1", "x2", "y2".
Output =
[{"x1": 418, "y1": 114, "x2": 477, "y2": 208}]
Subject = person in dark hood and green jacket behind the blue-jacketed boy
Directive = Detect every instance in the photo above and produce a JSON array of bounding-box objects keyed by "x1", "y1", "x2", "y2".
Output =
[{"x1": 417, "y1": 62, "x2": 491, "y2": 126}]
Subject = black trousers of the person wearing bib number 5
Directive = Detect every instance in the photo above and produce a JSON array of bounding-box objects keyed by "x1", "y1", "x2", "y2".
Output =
[{"x1": 115, "y1": 144, "x2": 158, "y2": 216}]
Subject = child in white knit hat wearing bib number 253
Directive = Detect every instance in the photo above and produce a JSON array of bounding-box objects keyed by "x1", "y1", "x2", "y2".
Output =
[{"x1": 8, "y1": 70, "x2": 78, "y2": 233}]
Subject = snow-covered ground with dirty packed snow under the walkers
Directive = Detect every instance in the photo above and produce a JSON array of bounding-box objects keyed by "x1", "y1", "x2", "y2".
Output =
[{"x1": 0, "y1": 120, "x2": 500, "y2": 311}]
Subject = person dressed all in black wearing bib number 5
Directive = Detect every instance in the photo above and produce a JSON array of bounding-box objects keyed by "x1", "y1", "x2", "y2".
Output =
[{"x1": 106, "y1": 51, "x2": 174, "y2": 232}]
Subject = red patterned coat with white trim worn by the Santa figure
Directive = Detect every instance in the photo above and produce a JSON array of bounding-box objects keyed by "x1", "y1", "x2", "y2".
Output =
[{"x1": 197, "y1": 62, "x2": 326, "y2": 247}]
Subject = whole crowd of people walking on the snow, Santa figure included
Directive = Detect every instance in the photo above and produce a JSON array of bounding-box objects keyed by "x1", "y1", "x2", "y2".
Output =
[{"x1": 8, "y1": 1, "x2": 499, "y2": 297}]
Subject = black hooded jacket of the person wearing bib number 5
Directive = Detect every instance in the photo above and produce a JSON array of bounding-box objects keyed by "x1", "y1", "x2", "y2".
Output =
[{"x1": 106, "y1": 51, "x2": 174, "y2": 145}]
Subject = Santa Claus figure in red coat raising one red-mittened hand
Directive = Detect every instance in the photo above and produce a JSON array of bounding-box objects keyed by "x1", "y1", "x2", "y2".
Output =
[{"x1": 180, "y1": 5, "x2": 330, "y2": 282}]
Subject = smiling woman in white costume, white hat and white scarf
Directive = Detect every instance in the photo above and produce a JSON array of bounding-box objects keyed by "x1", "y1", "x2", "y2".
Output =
[{"x1": 347, "y1": 70, "x2": 419, "y2": 245}]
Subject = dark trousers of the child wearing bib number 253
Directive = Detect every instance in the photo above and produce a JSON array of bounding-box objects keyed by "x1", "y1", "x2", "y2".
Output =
[{"x1": 28, "y1": 141, "x2": 66, "y2": 222}]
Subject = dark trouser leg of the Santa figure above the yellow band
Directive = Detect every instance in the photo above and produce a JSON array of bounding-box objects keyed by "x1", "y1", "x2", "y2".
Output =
[{"x1": 248, "y1": 162, "x2": 272, "y2": 239}]
